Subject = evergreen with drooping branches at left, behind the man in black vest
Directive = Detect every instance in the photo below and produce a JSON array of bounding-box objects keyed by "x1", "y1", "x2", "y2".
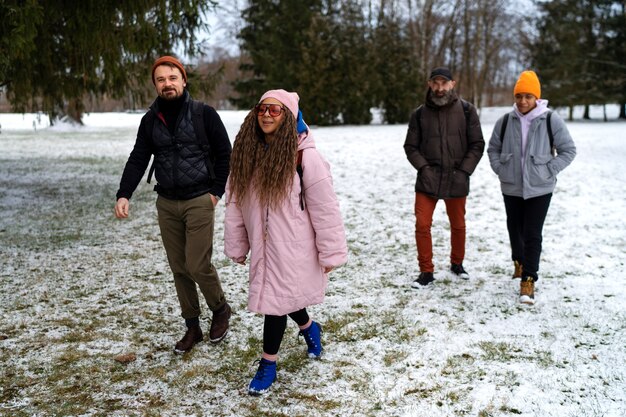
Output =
[{"x1": 0, "y1": 0, "x2": 215, "y2": 121}]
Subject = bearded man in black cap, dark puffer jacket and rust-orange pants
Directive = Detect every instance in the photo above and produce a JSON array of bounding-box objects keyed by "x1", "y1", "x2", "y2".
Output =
[{"x1": 404, "y1": 68, "x2": 485, "y2": 288}]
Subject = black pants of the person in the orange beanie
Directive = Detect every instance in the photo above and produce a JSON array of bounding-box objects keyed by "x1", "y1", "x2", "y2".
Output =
[{"x1": 504, "y1": 193, "x2": 552, "y2": 281}]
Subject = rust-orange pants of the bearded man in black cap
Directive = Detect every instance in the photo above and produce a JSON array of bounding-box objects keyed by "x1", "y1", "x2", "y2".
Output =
[{"x1": 415, "y1": 193, "x2": 467, "y2": 272}]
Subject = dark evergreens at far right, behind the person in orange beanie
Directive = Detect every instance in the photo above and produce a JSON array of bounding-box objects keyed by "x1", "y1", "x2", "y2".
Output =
[{"x1": 531, "y1": 0, "x2": 626, "y2": 118}]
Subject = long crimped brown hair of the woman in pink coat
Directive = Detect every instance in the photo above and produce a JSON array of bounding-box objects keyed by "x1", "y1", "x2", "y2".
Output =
[{"x1": 229, "y1": 109, "x2": 298, "y2": 208}]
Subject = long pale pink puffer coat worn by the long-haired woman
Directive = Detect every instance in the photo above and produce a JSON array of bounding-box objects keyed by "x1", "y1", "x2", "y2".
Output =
[{"x1": 224, "y1": 132, "x2": 348, "y2": 316}]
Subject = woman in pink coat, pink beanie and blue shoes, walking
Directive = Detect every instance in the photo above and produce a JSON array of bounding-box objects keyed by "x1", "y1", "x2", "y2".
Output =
[{"x1": 224, "y1": 90, "x2": 347, "y2": 395}]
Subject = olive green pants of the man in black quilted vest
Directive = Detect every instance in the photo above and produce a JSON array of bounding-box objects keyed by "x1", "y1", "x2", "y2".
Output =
[{"x1": 156, "y1": 193, "x2": 226, "y2": 319}]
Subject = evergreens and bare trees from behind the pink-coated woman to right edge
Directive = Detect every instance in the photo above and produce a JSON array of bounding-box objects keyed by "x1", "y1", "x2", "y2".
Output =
[{"x1": 234, "y1": 0, "x2": 626, "y2": 124}]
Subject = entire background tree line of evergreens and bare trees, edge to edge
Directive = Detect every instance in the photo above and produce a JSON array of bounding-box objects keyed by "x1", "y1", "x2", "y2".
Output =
[{"x1": 0, "y1": 0, "x2": 626, "y2": 125}]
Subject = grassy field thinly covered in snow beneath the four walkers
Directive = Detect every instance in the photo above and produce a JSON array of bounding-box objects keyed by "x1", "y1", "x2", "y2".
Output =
[{"x1": 0, "y1": 108, "x2": 626, "y2": 417}]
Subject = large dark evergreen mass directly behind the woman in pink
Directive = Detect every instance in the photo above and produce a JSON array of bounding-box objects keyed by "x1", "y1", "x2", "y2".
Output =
[{"x1": 233, "y1": 0, "x2": 373, "y2": 124}]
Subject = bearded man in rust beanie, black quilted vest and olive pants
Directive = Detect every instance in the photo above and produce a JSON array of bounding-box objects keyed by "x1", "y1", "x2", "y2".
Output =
[{"x1": 115, "y1": 56, "x2": 232, "y2": 353}]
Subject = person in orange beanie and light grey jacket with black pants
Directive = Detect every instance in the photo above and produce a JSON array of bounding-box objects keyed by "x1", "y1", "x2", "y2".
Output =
[{"x1": 487, "y1": 71, "x2": 576, "y2": 304}]
